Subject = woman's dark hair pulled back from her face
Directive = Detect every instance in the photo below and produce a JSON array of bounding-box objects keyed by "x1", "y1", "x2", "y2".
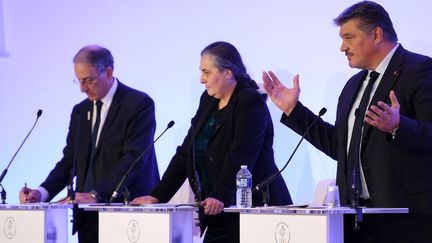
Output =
[{"x1": 201, "y1": 41, "x2": 258, "y2": 89}]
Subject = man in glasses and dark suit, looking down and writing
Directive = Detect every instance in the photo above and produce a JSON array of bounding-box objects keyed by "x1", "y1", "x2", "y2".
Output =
[{"x1": 20, "y1": 46, "x2": 159, "y2": 243}]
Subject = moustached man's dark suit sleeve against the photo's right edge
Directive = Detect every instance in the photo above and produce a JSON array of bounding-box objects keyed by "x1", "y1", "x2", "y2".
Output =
[{"x1": 394, "y1": 59, "x2": 432, "y2": 154}]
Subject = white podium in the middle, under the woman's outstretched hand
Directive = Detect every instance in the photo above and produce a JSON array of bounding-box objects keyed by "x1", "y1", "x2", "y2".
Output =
[{"x1": 83, "y1": 204, "x2": 196, "y2": 243}]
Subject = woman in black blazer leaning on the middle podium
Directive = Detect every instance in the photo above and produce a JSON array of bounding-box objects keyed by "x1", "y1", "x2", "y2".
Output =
[{"x1": 132, "y1": 42, "x2": 292, "y2": 242}]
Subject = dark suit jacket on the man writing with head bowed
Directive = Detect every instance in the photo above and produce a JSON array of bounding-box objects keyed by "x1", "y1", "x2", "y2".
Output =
[{"x1": 41, "y1": 82, "x2": 159, "y2": 201}]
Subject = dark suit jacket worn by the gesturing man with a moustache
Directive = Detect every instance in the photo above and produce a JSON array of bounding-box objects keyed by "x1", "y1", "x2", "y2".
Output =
[{"x1": 282, "y1": 46, "x2": 432, "y2": 213}]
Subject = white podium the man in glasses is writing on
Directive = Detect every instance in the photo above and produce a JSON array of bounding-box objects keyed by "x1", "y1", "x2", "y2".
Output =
[{"x1": 0, "y1": 203, "x2": 71, "y2": 243}]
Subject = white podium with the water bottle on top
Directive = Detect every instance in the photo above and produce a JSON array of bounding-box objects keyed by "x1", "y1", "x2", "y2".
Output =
[{"x1": 224, "y1": 207, "x2": 408, "y2": 243}]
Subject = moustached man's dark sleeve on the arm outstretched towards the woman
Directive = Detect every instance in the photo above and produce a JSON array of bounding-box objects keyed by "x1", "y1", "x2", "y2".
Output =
[{"x1": 281, "y1": 101, "x2": 338, "y2": 160}]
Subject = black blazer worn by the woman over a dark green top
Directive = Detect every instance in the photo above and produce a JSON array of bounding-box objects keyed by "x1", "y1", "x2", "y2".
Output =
[{"x1": 151, "y1": 83, "x2": 292, "y2": 206}]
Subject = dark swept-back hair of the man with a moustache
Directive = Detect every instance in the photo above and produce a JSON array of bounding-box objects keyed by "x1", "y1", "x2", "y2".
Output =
[{"x1": 334, "y1": 1, "x2": 398, "y2": 42}]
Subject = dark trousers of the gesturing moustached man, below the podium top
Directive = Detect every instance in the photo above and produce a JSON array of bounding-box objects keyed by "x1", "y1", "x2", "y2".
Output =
[{"x1": 344, "y1": 213, "x2": 432, "y2": 243}]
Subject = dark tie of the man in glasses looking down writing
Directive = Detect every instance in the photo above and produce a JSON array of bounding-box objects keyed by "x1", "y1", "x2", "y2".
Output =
[{"x1": 84, "y1": 100, "x2": 103, "y2": 192}]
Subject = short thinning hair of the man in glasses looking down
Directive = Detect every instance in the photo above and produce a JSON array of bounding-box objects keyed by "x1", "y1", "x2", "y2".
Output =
[{"x1": 73, "y1": 45, "x2": 114, "y2": 72}]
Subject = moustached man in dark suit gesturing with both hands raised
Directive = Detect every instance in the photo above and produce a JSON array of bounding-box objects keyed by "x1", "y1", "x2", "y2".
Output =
[{"x1": 263, "y1": 1, "x2": 432, "y2": 242}]
